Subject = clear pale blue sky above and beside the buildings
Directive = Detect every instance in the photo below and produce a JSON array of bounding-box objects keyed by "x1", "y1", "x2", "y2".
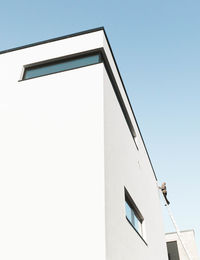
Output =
[{"x1": 0, "y1": 0, "x2": 200, "y2": 251}]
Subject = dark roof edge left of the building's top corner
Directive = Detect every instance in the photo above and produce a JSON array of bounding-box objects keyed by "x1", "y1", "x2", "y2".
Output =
[{"x1": 0, "y1": 27, "x2": 105, "y2": 54}]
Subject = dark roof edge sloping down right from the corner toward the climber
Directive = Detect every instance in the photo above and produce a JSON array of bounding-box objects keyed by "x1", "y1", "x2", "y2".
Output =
[{"x1": 103, "y1": 28, "x2": 158, "y2": 181}]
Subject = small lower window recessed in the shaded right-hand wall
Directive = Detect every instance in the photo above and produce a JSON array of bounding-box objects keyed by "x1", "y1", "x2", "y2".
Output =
[{"x1": 125, "y1": 189, "x2": 144, "y2": 237}]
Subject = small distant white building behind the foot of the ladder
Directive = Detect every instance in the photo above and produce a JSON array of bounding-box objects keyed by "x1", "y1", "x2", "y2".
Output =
[{"x1": 165, "y1": 230, "x2": 200, "y2": 260}]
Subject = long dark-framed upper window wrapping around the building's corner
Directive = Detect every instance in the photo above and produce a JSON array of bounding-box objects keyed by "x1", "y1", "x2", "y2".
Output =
[{"x1": 19, "y1": 48, "x2": 138, "y2": 149}]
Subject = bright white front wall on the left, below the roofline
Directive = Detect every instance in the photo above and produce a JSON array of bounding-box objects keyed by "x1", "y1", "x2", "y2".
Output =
[{"x1": 0, "y1": 34, "x2": 105, "y2": 260}]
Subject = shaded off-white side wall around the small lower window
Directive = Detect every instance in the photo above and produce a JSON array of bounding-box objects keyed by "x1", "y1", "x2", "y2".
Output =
[{"x1": 104, "y1": 66, "x2": 168, "y2": 260}]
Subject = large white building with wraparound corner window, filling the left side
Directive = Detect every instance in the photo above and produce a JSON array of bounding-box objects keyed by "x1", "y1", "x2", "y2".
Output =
[{"x1": 0, "y1": 28, "x2": 167, "y2": 260}]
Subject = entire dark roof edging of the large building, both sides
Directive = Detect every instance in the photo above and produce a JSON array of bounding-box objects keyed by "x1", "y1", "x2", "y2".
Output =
[{"x1": 0, "y1": 26, "x2": 157, "y2": 181}]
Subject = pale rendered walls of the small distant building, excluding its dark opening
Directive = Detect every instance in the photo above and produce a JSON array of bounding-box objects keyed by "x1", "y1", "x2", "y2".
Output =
[{"x1": 165, "y1": 230, "x2": 200, "y2": 260}]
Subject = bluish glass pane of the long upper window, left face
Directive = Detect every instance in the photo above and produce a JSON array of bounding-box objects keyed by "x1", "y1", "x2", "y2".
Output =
[{"x1": 23, "y1": 54, "x2": 102, "y2": 80}]
